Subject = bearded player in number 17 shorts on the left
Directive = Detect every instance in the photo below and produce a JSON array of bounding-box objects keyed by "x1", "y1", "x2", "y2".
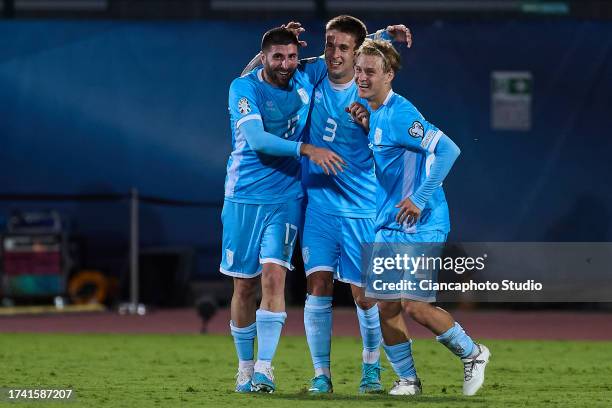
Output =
[{"x1": 220, "y1": 28, "x2": 344, "y2": 392}]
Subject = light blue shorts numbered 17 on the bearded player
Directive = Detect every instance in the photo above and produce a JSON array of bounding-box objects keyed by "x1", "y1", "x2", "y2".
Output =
[{"x1": 219, "y1": 200, "x2": 302, "y2": 278}]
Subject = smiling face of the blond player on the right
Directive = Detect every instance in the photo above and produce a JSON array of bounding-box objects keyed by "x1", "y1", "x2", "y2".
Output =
[{"x1": 355, "y1": 54, "x2": 394, "y2": 105}]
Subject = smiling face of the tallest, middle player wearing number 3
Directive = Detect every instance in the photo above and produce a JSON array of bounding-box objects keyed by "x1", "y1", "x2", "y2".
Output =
[{"x1": 325, "y1": 29, "x2": 357, "y2": 83}]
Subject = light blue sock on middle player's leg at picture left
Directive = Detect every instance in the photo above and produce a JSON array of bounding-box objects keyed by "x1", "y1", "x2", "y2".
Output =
[{"x1": 304, "y1": 295, "x2": 332, "y2": 370}]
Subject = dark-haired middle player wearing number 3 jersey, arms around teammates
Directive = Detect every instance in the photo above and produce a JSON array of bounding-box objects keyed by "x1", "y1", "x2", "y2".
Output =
[{"x1": 243, "y1": 19, "x2": 412, "y2": 393}]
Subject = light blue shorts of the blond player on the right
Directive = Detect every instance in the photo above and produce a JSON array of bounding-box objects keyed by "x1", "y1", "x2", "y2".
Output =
[{"x1": 366, "y1": 229, "x2": 448, "y2": 302}]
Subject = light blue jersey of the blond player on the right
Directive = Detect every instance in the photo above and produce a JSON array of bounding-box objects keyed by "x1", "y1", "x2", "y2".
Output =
[{"x1": 368, "y1": 91, "x2": 450, "y2": 233}]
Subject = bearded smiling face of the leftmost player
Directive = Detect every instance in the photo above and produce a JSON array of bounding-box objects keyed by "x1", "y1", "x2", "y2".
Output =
[{"x1": 261, "y1": 44, "x2": 298, "y2": 88}]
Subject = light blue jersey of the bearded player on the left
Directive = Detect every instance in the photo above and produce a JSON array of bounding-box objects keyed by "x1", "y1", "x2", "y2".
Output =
[{"x1": 225, "y1": 64, "x2": 323, "y2": 204}]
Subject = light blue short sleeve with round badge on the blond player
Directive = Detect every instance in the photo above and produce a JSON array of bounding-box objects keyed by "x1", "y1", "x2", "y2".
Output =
[{"x1": 390, "y1": 107, "x2": 444, "y2": 153}]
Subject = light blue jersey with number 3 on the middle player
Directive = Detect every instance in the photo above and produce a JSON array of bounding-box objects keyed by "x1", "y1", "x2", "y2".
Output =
[{"x1": 302, "y1": 58, "x2": 376, "y2": 218}]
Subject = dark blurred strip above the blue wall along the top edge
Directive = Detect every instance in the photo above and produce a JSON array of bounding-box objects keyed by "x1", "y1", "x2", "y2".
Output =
[{"x1": 0, "y1": 0, "x2": 612, "y2": 19}]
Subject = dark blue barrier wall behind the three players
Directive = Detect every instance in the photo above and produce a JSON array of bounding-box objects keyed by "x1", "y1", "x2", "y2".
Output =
[{"x1": 0, "y1": 21, "x2": 612, "y2": 276}]
